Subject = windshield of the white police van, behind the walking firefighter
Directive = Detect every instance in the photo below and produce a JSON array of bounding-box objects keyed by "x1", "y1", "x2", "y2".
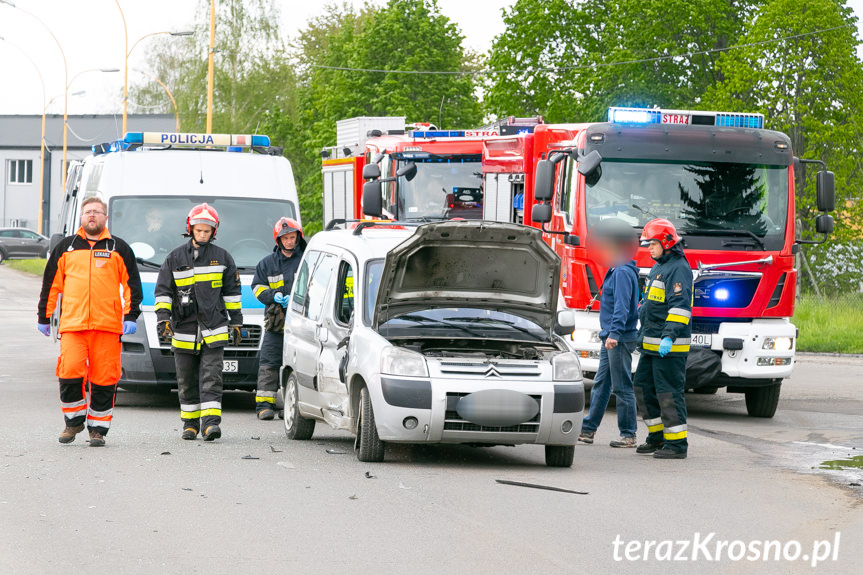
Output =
[{"x1": 108, "y1": 196, "x2": 296, "y2": 268}]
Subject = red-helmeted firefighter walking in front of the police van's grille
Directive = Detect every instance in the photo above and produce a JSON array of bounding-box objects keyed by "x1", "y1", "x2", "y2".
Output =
[{"x1": 155, "y1": 204, "x2": 243, "y2": 441}]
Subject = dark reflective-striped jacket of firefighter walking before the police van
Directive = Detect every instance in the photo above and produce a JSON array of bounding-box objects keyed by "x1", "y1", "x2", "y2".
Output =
[{"x1": 154, "y1": 240, "x2": 243, "y2": 353}]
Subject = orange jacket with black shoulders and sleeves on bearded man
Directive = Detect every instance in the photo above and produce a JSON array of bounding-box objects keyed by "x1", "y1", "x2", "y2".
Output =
[{"x1": 38, "y1": 228, "x2": 143, "y2": 334}]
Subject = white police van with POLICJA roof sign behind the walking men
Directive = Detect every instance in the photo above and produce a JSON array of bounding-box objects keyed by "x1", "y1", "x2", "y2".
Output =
[{"x1": 57, "y1": 132, "x2": 300, "y2": 391}]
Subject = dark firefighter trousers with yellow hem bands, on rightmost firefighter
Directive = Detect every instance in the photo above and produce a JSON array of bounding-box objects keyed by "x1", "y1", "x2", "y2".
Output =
[{"x1": 635, "y1": 352, "x2": 689, "y2": 451}]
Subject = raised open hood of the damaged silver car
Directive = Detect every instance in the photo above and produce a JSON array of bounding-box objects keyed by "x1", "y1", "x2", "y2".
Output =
[{"x1": 373, "y1": 220, "x2": 560, "y2": 334}]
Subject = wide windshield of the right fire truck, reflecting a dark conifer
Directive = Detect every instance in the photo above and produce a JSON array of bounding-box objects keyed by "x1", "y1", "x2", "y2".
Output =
[{"x1": 576, "y1": 159, "x2": 789, "y2": 250}]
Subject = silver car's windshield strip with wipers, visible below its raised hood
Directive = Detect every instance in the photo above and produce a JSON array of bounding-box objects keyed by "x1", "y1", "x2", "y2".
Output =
[{"x1": 378, "y1": 307, "x2": 548, "y2": 341}]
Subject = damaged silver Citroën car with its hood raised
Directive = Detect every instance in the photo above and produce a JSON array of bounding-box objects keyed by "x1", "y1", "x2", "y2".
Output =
[{"x1": 281, "y1": 221, "x2": 584, "y2": 467}]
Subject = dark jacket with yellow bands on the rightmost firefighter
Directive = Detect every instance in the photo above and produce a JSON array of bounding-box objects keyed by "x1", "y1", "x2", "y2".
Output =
[{"x1": 638, "y1": 243, "x2": 692, "y2": 355}]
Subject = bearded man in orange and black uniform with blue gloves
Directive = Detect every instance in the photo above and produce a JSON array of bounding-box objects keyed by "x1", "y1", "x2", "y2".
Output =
[{"x1": 38, "y1": 197, "x2": 142, "y2": 447}]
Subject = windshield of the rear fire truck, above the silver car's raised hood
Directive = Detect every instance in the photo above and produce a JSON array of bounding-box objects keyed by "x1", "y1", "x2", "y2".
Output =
[{"x1": 390, "y1": 154, "x2": 482, "y2": 220}]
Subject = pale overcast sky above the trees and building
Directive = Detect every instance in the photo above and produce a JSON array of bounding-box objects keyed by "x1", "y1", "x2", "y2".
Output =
[{"x1": 0, "y1": 0, "x2": 863, "y2": 114}]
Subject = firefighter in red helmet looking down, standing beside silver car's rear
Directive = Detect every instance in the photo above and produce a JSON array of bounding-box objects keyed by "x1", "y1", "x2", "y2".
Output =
[{"x1": 252, "y1": 218, "x2": 306, "y2": 419}]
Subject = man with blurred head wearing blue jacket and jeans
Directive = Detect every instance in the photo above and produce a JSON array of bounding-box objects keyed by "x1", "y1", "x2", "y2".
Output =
[{"x1": 578, "y1": 219, "x2": 638, "y2": 447}]
